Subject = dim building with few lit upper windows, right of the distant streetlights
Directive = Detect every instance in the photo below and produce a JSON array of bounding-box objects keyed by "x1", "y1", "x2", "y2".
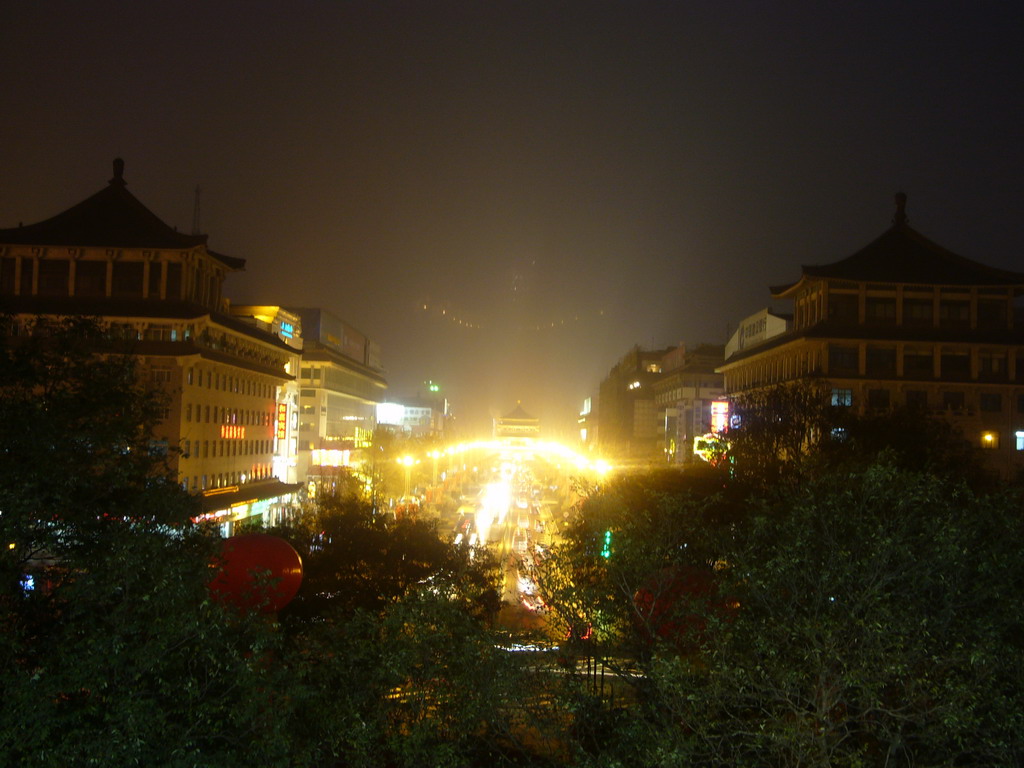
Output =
[{"x1": 597, "y1": 346, "x2": 672, "y2": 460}]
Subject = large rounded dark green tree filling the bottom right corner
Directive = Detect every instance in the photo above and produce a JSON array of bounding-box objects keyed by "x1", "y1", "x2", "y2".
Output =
[{"x1": 655, "y1": 457, "x2": 1024, "y2": 766}]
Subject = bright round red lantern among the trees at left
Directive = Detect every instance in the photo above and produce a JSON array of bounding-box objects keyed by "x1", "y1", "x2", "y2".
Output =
[{"x1": 210, "y1": 534, "x2": 302, "y2": 613}]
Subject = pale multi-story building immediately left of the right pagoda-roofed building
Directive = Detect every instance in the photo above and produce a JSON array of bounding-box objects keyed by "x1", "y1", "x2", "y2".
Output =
[{"x1": 651, "y1": 344, "x2": 725, "y2": 464}]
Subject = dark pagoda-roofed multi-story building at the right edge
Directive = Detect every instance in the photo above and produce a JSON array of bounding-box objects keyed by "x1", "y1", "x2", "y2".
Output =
[{"x1": 719, "y1": 195, "x2": 1024, "y2": 477}]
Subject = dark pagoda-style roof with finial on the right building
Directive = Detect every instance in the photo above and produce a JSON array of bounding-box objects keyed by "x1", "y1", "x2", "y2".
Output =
[{"x1": 771, "y1": 193, "x2": 1024, "y2": 299}]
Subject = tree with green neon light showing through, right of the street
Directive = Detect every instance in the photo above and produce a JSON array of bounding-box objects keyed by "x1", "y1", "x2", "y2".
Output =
[{"x1": 539, "y1": 468, "x2": 749, "y2": 671}]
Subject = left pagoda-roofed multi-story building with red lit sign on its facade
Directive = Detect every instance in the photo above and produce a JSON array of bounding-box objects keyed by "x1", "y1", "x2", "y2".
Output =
[{"x1": 0, "y1": 160, "x2": 298, "y2": 528}]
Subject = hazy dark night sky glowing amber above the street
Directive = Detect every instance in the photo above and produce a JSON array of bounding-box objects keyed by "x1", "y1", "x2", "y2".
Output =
[{"x1": 0, "y1": 0, "x2": 1024, "y2": 431}]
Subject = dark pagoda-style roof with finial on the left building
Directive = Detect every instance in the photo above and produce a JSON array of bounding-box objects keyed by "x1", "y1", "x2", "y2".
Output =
[{"x1": 0, "y1": 158, "x2": 246, "y2": 269}]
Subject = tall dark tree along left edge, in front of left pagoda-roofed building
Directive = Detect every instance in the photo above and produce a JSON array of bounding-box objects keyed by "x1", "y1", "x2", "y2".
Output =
[{"x1": 0, "y1": 319, "x2": 299, "y2": 766}]
